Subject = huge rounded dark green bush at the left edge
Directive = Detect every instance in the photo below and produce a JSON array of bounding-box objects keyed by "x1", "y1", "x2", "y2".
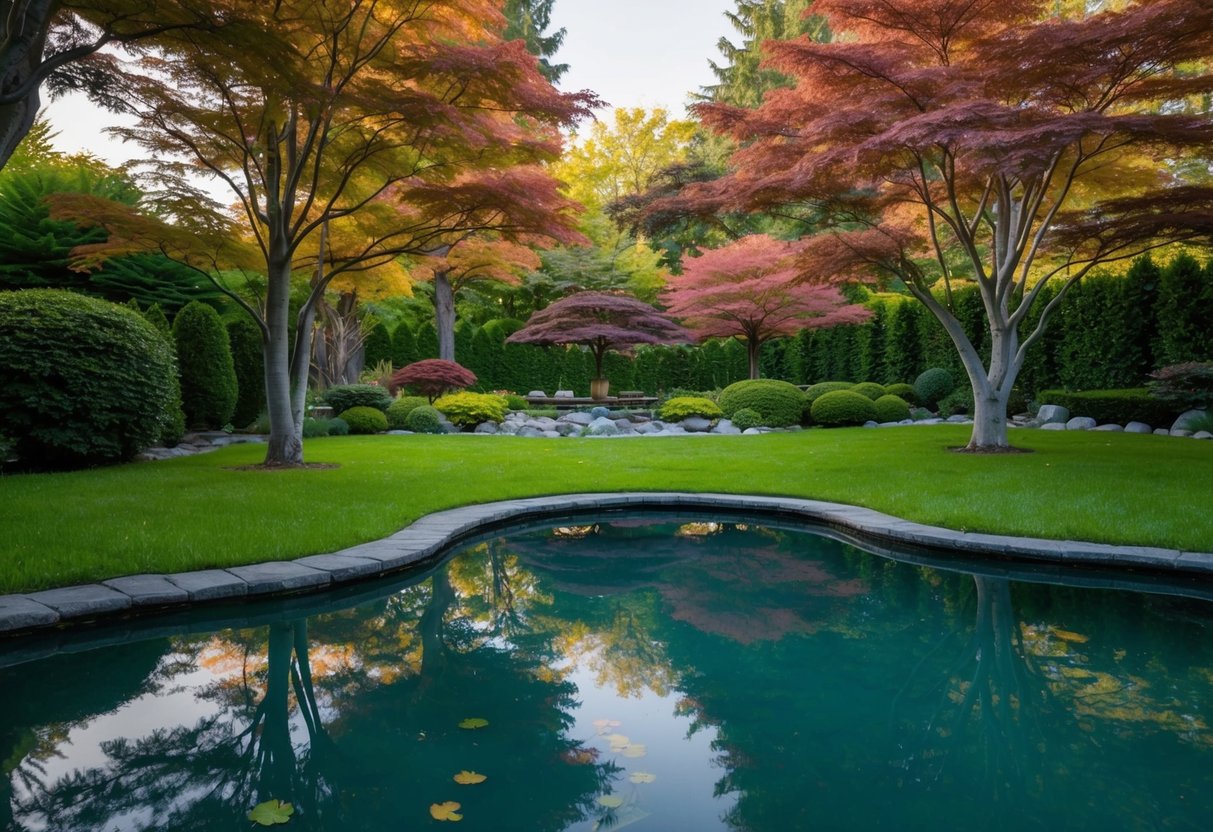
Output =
[{"x1": 0, "y1": 289, "x2": 177, "y2": 469}]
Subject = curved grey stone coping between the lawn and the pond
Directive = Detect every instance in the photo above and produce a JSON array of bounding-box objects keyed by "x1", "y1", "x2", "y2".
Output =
[{"x1": 0, "y1": 491, "x2": 1213, "y2": 637}]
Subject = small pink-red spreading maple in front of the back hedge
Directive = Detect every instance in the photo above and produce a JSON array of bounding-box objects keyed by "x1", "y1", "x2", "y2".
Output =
[{"x1": 662, "y1": 234, "x2": 871, "y2": 378}]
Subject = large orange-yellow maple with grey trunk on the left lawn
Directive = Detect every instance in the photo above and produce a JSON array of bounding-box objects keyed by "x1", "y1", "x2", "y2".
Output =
[{"x1": 54, "y1": 0, "x2": 597, "y2": 465}]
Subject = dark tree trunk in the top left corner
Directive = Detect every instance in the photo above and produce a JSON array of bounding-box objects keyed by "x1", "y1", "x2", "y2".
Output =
[{"x1": 0, "y1": 0, "x2": 53, "y2": 169}]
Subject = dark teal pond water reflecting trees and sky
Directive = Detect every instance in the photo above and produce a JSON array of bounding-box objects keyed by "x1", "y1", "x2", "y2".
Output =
[{"x1": 0, "y1": 515, "x2": 1213, "y2": 832}]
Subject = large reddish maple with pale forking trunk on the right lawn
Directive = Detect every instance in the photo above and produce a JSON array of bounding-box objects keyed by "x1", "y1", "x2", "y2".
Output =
[{"x1": 653, "y1": 0, "x2": 1213, "y2": 451}]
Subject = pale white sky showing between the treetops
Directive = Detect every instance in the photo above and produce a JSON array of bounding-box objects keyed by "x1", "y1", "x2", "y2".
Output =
[{"x1": 47, "y1": 0, "x2": 735, "y2": 165}]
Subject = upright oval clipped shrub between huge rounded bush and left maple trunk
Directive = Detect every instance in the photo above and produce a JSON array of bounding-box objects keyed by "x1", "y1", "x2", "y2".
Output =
[{"x1": 172, "y1": 301, "x2": 238, "y2": 429}]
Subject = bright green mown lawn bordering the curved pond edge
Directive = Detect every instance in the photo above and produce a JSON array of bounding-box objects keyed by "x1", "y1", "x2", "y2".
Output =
[{"x1": 0, "y1": 426, "x2": 1213, "y2": 592}]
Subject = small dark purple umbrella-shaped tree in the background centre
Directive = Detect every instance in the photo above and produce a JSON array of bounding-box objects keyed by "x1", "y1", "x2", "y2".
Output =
[{"x1": 506, "y1": 292, "x2": 691, "y2": 398}]
